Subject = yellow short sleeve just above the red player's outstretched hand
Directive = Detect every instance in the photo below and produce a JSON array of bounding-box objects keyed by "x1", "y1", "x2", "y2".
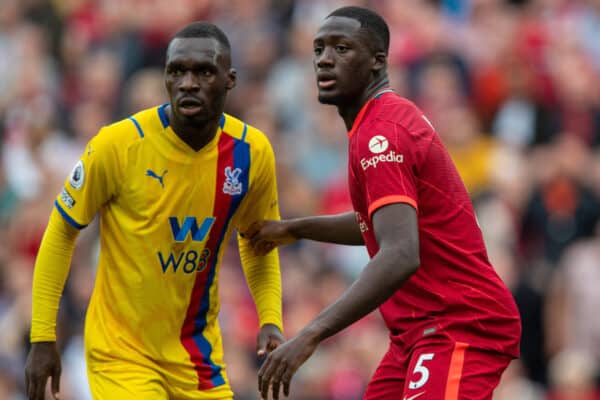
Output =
[{"x1": 237, "y1": 137, "x2": 280, "y2": 232}]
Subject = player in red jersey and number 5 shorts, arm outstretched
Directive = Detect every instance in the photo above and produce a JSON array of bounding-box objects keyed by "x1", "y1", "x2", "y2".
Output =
[{"x1": 245, "y1": 7, "x2": 521, "y2": 400}]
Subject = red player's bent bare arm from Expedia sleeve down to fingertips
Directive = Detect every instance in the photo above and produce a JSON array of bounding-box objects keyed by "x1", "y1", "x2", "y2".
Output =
[{"x1": 258, "y1": 203, "x2": 420, "y2": 399}]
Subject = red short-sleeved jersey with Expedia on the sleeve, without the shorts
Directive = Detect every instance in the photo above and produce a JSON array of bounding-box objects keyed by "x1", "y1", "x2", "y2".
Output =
[{"x1": 348, "y1": 90, "x2": 521, "y2": 357}]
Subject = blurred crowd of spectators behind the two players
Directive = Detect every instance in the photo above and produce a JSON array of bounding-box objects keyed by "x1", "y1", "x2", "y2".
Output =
[{"x1": 0, "y1": 0, "x2": 600, "y2": 400}]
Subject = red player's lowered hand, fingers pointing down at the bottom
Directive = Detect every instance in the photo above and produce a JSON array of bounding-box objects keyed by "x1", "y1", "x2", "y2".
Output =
[{"x1": 258, "y1": 334, "x2": 319, "y2": 400}]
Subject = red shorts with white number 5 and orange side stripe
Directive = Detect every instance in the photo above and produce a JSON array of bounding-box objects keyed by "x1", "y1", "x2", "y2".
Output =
[{"x1": 363, "y1": 340, "x2": 512, "y2": 400}]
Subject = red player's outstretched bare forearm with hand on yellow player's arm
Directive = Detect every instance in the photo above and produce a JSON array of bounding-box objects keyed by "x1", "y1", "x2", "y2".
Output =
[{"x1": 244, "y1": 212, "x2": 364, "y2": 254}]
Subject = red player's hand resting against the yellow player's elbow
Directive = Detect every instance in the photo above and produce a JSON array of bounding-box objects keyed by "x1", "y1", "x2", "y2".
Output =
[{"x1": 243, "y1": 220, "x2": 297, "y2": 256}]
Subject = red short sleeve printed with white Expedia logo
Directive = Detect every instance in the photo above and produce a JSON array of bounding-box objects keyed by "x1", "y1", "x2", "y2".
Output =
[{"x1": 355, "y1": 123, "x2": 418, "y2": 218}]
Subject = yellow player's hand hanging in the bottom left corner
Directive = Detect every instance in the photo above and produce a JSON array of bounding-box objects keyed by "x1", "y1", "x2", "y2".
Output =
[{"x1": 25, "y1": 342, "x2": 61, "y2": 400}]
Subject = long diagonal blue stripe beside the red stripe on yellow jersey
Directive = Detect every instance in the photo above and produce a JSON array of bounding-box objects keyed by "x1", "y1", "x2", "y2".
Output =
[{"x1": 194, "y1": 139, "x2": 250, "y2": 386}]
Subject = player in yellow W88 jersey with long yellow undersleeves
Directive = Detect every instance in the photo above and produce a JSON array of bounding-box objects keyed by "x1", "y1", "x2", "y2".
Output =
[{"x1": 26, "y1": 22, "x2": 284, "y2": 400}]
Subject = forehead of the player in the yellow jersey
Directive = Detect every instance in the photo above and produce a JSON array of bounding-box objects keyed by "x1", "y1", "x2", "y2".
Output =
[{"x1": 167, "y1": 37, "x2": 229, "y2": 65}]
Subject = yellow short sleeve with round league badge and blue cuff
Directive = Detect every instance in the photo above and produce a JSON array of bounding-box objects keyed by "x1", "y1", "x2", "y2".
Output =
[{"x1": 55, "y1": 128, "x2": 122, "y2": 229}]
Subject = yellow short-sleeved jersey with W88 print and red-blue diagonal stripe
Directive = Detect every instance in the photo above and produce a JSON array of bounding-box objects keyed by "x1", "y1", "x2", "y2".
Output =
[{"x1": 55, "y1": 105, "x2": 279, "y2": 398}]
